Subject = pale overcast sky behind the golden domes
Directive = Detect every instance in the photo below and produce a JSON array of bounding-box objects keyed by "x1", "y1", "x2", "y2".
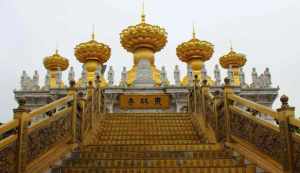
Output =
[{"x1": 0, "y1": 0, "x2": 300, "y2": 121}]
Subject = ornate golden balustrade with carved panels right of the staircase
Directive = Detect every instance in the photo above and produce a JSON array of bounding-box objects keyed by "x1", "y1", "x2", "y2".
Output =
[{"x1": 192, "y1": 79, "x2": 300, "y2": 172}]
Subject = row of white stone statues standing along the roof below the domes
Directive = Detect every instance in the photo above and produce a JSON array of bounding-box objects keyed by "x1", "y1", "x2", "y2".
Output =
[{"x1": 20, "y1": 64, "x2": 272, "y2": 91}]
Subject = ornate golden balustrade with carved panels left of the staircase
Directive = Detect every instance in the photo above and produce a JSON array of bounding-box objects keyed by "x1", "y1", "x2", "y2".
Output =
[{"x1": 0, "y1": 82, "x2": 102, "y2": 173}]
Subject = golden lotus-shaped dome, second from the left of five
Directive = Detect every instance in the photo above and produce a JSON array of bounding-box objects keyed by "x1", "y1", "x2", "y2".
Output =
[{"x1": 75, "y1": 34, "x2": 111, "y2": 64}]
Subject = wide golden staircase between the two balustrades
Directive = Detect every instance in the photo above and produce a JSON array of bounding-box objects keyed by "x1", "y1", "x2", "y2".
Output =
[{"x1": 52, "y1": 113, "x2": 251, "y2": 173}]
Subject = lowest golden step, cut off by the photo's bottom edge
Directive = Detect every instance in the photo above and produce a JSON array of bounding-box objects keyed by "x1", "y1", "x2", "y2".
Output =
[{"x1": 56, "y1": 165, "x2": 246, "y2": 173}]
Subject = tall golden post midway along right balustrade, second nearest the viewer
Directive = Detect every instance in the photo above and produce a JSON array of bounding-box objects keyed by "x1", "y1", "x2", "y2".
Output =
[{"x1": 224, "y1": 78, "x2": 233, "y2": 142}]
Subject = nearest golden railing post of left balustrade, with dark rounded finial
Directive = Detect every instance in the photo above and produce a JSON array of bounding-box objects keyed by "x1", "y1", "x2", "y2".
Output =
[{"x1": 14, "y1": 98, "x2": 29, "y2": 173}]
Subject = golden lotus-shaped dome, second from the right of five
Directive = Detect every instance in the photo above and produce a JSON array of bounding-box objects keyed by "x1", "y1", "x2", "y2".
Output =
[{"x1": 176, "y1": 32, "x2": 214, "y2": 62}]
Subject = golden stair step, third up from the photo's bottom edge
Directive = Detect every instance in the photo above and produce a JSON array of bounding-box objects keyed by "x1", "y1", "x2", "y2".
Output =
[{"x1": 77, "y1": 151, "x2": 232, "y2": 159}]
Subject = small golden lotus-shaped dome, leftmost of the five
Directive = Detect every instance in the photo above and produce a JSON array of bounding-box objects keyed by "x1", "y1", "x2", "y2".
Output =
[{"x1": 44, "y1": 50, "x2": 69, "y2": 71}]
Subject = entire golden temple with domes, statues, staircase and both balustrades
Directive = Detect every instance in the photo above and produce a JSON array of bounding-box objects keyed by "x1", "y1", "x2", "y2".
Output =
[{"x1": 0, "y1": 5, "x2": 300, "y2": 173}]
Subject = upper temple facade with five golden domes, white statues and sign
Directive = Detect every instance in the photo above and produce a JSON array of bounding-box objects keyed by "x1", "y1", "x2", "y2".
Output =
[{"x1": 14, "y1": 9, "x2": 279, "y2": 120}]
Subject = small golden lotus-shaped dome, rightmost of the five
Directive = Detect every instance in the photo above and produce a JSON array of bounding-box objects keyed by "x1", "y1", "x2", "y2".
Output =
[{"x1": 219, "y1": 48, "x2": 247, "y2": 69}]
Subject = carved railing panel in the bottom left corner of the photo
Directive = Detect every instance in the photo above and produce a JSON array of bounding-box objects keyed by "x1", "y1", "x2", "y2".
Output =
[{"x1": 0, "y1": 141, "x2": 18, "y2": 173}]
